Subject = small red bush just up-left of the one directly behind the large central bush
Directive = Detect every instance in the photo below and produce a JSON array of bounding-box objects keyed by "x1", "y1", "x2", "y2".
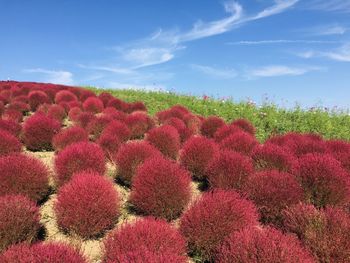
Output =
[{"x1": 125, "y1": 112, "x2": 155, "y2": 139}]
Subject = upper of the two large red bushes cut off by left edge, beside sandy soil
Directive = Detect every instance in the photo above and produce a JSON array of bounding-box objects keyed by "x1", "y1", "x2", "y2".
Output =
[{"x1": 0, "y1": 154, "x2": 49, "y2": 201}]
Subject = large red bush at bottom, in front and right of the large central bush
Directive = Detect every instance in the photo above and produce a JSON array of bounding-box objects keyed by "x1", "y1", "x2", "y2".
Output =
[{"x1": 180, "y1": 190, "x2": 258, "y2": 261}]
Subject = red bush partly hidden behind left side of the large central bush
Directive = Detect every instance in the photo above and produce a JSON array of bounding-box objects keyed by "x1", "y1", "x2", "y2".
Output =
[{"x1": 114, "y1": 141, "x2": 161, "y2": 185}]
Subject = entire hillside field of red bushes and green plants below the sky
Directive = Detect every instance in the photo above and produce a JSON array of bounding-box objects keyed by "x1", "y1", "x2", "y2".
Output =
[{"x1": 0, "y1": 81, "x2": 350, "y2": 263}]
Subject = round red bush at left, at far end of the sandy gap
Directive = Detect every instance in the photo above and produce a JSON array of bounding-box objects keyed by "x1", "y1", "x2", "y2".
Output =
[{"x1": 23, "y1": 113, "x2": 61, "y2": 151}]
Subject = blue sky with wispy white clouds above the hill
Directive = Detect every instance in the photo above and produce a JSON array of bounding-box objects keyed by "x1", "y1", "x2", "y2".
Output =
[{"x1": 0, "y1": 0, "x2": 350, "y2": 109}]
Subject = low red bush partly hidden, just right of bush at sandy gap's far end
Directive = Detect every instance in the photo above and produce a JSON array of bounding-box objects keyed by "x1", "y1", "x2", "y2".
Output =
[{"x1": 52, "y1": 126, "x2": 89, "y2": 151}]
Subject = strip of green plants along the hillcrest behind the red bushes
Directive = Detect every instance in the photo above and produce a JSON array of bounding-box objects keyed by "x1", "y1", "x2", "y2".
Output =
[{"x1": 89, "y1": 87, "x2": 350, "y2": 141}]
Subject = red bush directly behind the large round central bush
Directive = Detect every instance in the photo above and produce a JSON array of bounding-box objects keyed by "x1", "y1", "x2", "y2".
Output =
[{"x1": 146, "y1": 125, "x2": 181, "y2": 159}]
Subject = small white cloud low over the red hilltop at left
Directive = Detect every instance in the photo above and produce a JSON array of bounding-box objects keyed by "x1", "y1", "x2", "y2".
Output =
[{"x1": 23, "y1": 68, "x2": 74, "y2": 85}]
